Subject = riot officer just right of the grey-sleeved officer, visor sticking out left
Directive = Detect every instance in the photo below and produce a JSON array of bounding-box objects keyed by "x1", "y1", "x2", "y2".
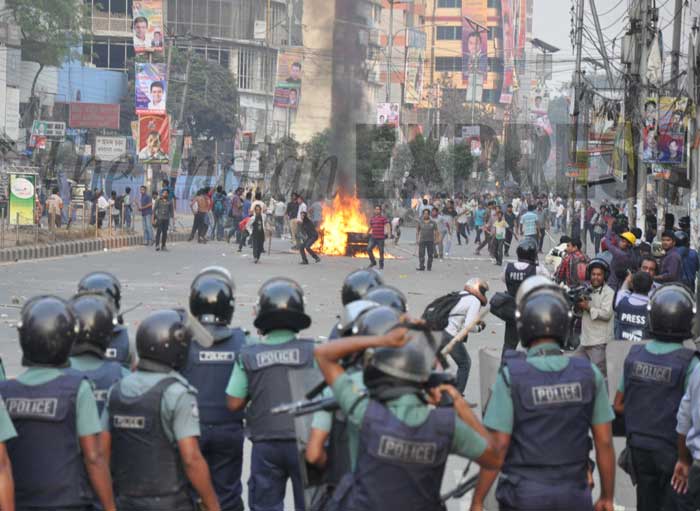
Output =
[{"x1": 182, "y1": 268, "x2": 246, "y2": 511}]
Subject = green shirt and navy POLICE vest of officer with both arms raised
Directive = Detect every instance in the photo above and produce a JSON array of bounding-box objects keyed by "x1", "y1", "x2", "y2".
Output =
[{"x1": 332, "y1": 373, "x2": 486, "y2": 510}]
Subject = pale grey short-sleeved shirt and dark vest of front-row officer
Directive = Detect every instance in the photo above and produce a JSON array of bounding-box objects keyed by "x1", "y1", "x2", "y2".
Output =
[{"x1": 102, "y1": 361, "x2": 200, "y2": 511}]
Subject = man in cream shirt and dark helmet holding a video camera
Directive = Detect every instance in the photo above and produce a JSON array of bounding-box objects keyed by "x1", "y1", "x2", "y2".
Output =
[{"x1": 575, "y1": 258, "x2": 615, "y2": 377}]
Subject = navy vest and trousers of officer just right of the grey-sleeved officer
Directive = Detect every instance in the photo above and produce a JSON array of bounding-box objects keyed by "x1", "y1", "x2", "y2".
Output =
[{"x1": 182, "y1": 326, "x2": 246, "y2": 511}]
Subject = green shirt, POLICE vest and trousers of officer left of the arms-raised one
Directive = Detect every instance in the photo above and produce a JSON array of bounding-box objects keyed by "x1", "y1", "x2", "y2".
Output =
[{"x1": 226, "y1": 329, "x2": 314, "y2": 511}]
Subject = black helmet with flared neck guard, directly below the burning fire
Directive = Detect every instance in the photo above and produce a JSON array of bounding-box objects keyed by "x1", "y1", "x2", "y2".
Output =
[{"x1": 253, "y1": 277, "x2": 311, "y2": 334}]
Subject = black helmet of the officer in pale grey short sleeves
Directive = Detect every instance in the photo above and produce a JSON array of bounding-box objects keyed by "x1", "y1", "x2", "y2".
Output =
[{"x1": 136, "y1": 309, "x2": 192, "y2": 370}]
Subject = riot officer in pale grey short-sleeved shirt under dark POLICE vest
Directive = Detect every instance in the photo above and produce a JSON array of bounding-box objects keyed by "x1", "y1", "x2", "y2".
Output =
[{"x1": 102, "y1": 310, "x2": 220, "y2": 511}]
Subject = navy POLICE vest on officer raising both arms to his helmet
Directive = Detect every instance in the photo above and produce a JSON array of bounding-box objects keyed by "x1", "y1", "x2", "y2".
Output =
[{"x1": 333, "y1": 400, "x2": 455, "y2": 511}]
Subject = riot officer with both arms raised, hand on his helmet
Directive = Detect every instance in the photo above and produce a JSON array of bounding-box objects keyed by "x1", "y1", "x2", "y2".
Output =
[{"x1": 315, "y1": 316, "x2": 499, "y2": 511}]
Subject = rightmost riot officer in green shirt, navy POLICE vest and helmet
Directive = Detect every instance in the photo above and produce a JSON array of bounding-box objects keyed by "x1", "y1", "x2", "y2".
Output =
[{"x1": 615, "y1": 284, "x2": 698, "y2": 511}]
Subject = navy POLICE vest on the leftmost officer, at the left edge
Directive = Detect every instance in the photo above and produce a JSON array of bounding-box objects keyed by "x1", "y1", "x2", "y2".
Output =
[{"x1": 0, "y1": 370, "x2": 92, "y2": 509}]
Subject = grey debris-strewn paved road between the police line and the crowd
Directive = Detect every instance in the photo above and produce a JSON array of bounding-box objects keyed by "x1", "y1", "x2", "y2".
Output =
[{"x1": 0, "y1": 233, "x2": 636, "y2": 510}]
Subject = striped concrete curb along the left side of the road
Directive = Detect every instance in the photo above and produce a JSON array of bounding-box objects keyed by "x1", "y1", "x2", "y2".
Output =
[{"x1": 0, "y1": 232, "x2": 182, "y2": 263}]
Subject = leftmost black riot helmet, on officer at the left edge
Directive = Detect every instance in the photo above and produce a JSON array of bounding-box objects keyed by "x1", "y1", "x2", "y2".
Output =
[{"x1": 17, "y1": 296, "x2": 79, "y2": 367}]
